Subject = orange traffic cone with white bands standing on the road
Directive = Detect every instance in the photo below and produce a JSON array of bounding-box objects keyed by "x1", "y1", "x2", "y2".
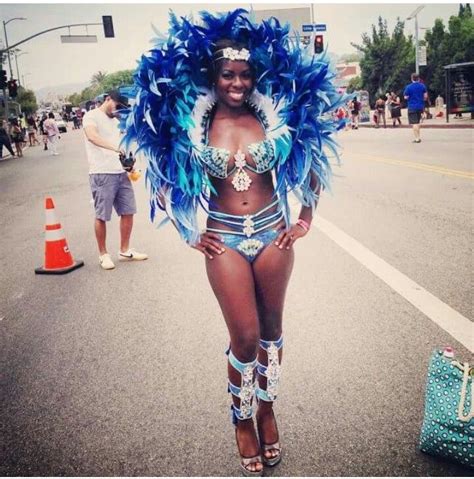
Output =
[{"x1": 35, "y1": 198, "x2": 84, "y2": 274}]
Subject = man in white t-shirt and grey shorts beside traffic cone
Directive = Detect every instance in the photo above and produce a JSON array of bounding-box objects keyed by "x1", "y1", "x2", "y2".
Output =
[{"x1": 82, "y1": 90, "x2": 148, "y2": 269}]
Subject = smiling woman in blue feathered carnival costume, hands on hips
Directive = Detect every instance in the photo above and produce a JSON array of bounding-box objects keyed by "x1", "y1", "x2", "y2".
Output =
[{"x1": 122, "y1": 9, "x2": 344, "y2": 476}]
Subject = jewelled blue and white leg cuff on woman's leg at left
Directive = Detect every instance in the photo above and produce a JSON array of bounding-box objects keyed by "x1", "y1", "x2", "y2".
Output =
[{"x1": 227, "y1": 349, "x2": 257, "y2": 424}]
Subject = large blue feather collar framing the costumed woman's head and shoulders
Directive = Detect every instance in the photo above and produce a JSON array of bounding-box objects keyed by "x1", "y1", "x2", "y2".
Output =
[{"x1": 121, "y1": 9, "x2": 344, "y2": 244}]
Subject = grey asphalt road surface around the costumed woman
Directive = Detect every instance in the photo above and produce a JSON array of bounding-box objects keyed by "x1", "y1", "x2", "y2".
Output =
[{"x1": 0, "y1": 125, "x2": 473, "y2": 476}]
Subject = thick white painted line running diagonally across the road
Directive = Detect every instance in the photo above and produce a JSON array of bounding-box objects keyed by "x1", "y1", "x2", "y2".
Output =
[{"x1": 315, "y1": 216, "x2": 474, "y2": 352}]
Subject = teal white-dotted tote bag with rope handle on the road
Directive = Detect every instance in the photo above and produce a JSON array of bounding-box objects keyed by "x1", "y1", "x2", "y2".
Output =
[{"x1": 420, "y1": 348, "x2": 474, "y2": 468}]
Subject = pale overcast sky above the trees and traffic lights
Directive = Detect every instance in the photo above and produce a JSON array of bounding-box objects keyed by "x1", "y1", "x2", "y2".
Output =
[{"x1": 0, "y1": 1, "x2": 459, "y2": 90}]
